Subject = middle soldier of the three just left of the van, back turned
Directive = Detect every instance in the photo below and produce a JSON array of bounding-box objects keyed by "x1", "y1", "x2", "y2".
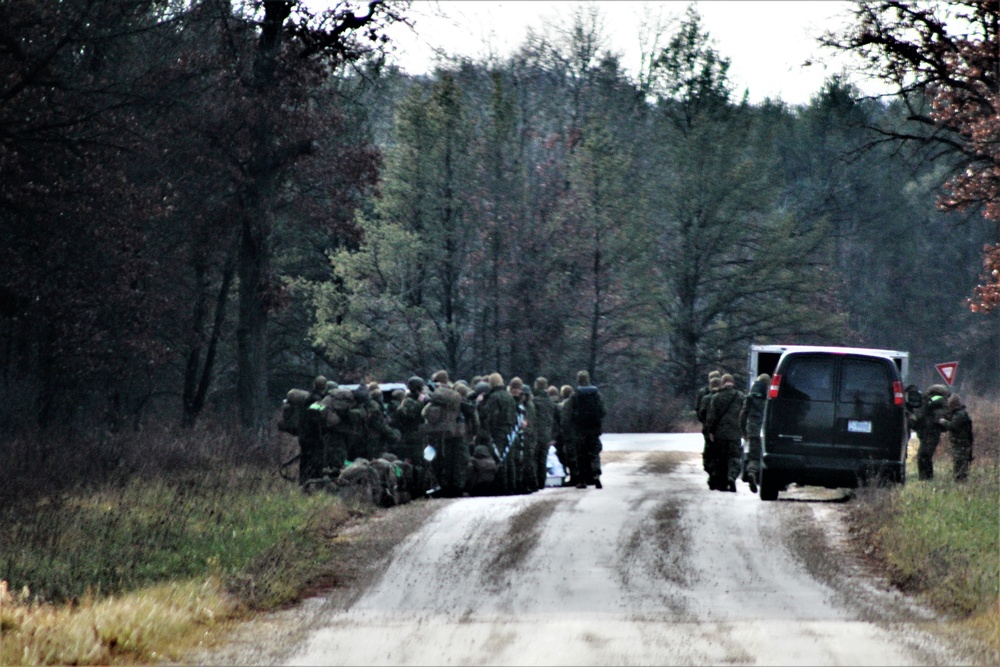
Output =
[{"x1": 705, "y1": 373, "x2": 745, "y2": 492}]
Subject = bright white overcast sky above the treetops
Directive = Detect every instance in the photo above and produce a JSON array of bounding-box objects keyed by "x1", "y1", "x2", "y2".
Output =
[{"x1": 378, "y1": 0, "x2": 878, "y2": 104}]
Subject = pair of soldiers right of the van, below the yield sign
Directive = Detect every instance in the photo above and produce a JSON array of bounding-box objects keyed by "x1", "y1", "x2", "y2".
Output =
[{"x1": 905, "y1": 384, "x2": 974, "y2": 482}]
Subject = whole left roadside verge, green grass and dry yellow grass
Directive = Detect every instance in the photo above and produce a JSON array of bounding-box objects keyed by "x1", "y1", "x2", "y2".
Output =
[{"x1": 0, "y1": 466, "x2": 370, "y2": 665}]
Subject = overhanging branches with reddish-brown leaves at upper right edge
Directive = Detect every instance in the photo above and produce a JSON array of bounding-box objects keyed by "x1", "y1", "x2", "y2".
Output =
[{"x1": 824, "y1": 0, "x2": 1000, "y2": 312}]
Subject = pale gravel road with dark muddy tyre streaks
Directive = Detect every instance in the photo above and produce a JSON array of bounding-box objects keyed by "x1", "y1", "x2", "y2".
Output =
[{"x1": 207, "y1": 434, "x2": 984, "y2": 665}]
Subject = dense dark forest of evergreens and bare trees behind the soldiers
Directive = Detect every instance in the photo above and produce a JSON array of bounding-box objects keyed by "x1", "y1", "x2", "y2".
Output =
[{"x1": 0, "y1": 0, "x2": 1000, "y2": 447}]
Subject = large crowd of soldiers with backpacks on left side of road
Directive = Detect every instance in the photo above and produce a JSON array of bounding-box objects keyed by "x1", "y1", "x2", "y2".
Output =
[{"x1": 278, "y1": 370, "x2": 605, "y2": 505}]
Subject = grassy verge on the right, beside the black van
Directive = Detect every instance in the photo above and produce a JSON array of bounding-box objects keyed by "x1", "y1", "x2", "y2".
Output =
[{"x1": 850, "y1": 401, "x2": 1000, "y2": 652}]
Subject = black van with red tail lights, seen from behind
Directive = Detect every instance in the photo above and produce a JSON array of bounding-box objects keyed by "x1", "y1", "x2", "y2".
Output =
[{"x1": 760, "y1": 348, "x2": 907, "y2": 500}]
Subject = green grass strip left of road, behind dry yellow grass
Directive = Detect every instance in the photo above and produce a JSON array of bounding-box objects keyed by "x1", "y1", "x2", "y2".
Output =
[{"x1": 0, "y1": 467, "x2": 348, "y2": 602}]
